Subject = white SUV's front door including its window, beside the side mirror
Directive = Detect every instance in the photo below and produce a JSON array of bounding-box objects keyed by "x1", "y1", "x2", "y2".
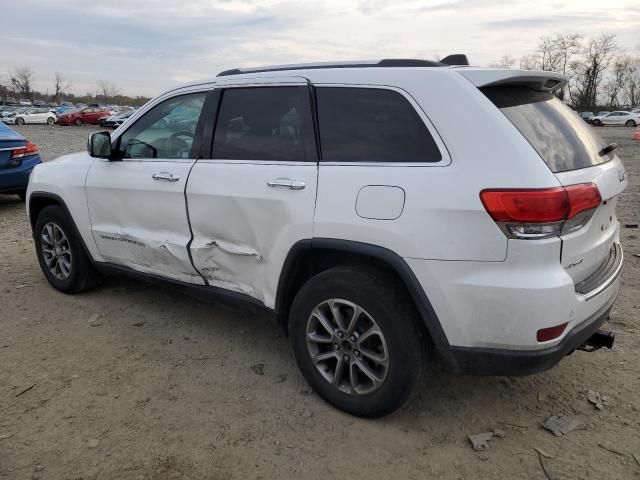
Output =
[{"x1": 86, "y1": 91, "x2": 207, "y2": 284}]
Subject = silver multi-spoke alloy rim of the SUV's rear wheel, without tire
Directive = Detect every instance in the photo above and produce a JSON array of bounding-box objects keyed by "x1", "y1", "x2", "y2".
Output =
[{"x1": 306, "y1": 298, "x2": 389, "y2": 395}]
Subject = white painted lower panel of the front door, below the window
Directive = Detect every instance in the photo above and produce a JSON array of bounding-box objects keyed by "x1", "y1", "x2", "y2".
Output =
[{"x1": 86, "y1": 160, "x2": 204, "y2": 285}]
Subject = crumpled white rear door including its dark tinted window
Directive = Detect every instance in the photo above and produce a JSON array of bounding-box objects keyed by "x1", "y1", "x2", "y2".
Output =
[{"x1": 187, "y1": 78, "x2": 318, "y2": 307}]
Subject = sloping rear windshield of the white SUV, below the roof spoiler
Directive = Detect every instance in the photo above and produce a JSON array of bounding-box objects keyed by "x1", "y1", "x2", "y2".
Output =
[{"x1": 480, "y1": 85, "x2": 611, "y2": 172}]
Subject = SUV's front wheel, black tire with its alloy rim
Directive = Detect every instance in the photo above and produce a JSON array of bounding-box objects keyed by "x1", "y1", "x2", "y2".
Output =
[{"x1": 34, "y1": 205, "x2": 101, "y2": 293}]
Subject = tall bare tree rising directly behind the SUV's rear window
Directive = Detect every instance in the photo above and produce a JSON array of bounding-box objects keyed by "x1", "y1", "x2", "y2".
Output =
[{"x1": 569, "y1": 34, "x2": 617, "y2": 111}]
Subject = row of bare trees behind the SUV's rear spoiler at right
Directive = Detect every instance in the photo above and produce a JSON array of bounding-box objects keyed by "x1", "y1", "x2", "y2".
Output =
[{"x1": 492, "y1": 33, "x2": 640, "y2": 112}]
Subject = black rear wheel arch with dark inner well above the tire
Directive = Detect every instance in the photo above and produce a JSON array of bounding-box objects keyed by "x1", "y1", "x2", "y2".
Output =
[{"x1": 275, "y1": 238, "x2": 449, "y2": 354}]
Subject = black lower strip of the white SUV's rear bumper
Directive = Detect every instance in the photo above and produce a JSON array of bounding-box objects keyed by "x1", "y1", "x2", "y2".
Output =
[{"x1": 443, "y1": 298, "x2": 615, "y2": 376}]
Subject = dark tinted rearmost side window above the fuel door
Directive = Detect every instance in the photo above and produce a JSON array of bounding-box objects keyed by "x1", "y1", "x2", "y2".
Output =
[{"x1": 316, "y1": 87, "x2": 442, "y2": 162}]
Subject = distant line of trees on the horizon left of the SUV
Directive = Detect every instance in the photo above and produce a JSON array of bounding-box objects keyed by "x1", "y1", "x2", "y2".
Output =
[{"x1": 0, "y1": 65, "x2": 149, "y2": 106}]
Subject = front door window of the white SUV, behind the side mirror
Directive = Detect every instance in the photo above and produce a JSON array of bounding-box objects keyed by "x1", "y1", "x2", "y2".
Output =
[{"x1": 118, "y1": 92, "x2": 207, "y2": 159}]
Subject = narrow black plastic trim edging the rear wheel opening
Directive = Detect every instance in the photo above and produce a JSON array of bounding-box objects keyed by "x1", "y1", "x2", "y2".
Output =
[{"x1": 276, "y1": 238, "x2": 449, "y2": 352}]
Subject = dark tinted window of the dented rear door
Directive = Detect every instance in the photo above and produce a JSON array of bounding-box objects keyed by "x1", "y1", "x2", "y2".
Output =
[{"x1": 213, "y1": 86, "x2": 317, "y2": 162}]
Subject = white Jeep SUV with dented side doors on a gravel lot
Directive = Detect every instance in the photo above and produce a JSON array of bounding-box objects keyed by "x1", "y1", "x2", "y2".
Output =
[{"x1": 27, "y1": 59, "x2": 627, "y2": 417}]
